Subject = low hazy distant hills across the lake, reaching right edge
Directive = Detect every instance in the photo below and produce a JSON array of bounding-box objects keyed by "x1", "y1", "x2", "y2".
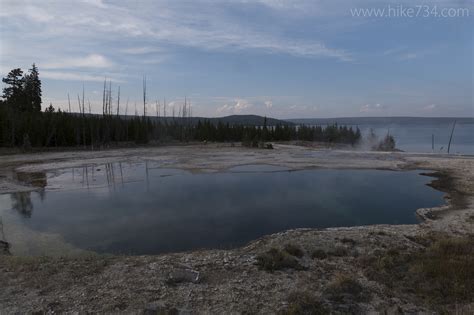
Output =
[{"x1": 286, "y1": 117, "x2": 474, "y2": 125}]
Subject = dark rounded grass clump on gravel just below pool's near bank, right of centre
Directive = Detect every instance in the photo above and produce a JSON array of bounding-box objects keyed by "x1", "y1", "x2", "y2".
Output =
[{"x1": 257, "y1": 247, "x2": 304, "y2": 272}]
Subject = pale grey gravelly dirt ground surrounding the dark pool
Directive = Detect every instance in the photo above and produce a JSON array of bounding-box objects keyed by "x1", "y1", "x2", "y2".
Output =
[{"x1": 0, "y1": 144, "x2": 474, "y2": 314}]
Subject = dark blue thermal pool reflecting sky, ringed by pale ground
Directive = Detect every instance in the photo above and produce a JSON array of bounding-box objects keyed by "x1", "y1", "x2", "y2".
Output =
[{"x1": 0, "y1": 162, "x2": 443, "y2": 255}]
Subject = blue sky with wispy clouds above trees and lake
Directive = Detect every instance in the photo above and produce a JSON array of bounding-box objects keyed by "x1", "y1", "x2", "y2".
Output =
[{"x1": 0, "y1": 0, "x2": 474, "y2": 118}]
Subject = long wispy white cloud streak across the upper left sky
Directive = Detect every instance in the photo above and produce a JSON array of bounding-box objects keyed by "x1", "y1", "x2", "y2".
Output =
[{"x1": 2, "y1": 0, "x2": 351, "y2": 61}]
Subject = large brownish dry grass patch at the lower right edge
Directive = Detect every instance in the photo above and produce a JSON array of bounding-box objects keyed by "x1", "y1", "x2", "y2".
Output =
[{"x1": 359, "y1": 235, "x2": 474, "y2": 307}]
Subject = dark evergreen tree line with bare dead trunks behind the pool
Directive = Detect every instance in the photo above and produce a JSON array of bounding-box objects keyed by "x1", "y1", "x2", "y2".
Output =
[{"x1": 0, "y1": 64, "x2": 361, "y2": 149}]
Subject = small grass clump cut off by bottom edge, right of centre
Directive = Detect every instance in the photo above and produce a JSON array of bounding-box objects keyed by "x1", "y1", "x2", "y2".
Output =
[{"x1": 280, "y1": 292, "x2": 329, "y2": 315}]
